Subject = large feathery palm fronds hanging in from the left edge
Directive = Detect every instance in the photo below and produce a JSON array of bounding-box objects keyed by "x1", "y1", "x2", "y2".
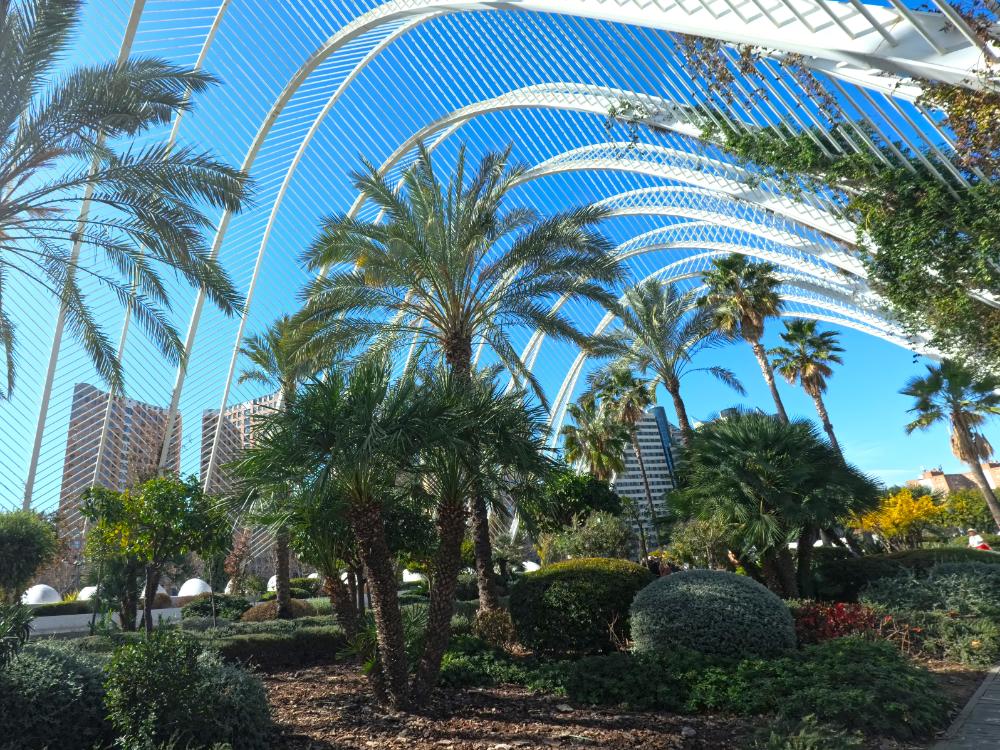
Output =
[{"x1": 0, "y1": 0, "x2": 248, "y2": 397}]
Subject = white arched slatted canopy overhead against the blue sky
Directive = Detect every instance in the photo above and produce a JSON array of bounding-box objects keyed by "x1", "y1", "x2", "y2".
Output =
[{"x1": 0, "y1": 0, "x2": 996, "y2": 528}]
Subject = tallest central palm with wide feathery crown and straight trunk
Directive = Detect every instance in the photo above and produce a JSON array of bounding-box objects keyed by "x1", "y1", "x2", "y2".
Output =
[{"x1": 300, "y1": 146, "x2": 623, "y2": 608}]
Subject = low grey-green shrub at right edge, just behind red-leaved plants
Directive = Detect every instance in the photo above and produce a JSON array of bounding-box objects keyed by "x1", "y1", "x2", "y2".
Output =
[{"x1": 859, "y1": 563, "x2": 1000, "y2": 616}]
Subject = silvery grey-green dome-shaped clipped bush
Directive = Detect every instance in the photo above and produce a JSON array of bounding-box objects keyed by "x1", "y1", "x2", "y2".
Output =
[{"x1": 631, "y1": 570, "x2": 795, "y2": 657}]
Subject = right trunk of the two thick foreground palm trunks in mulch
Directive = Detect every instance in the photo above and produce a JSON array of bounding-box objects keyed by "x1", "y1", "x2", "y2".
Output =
[{"x1": 412, "y1": 498, "x2": 466, "y2": 705}]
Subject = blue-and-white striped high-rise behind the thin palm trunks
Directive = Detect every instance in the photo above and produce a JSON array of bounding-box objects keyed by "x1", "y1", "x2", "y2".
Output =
[{"x1": 611, "y1": 406, "x2": 676, "y2": 548}]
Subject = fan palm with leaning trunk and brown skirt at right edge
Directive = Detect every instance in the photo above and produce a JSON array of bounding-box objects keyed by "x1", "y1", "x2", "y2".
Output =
[{"x1": 900, "y1": 359, "x2": 1000, "y2": 528}]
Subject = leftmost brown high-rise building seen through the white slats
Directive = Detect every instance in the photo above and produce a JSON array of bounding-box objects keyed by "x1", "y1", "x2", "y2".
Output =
[{"x1": 59, "y1": 383, "x2": 181, "y2": 544}]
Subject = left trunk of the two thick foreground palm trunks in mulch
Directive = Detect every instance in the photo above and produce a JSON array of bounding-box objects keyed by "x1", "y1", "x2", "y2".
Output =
[{"x1": 351, "y1": 502, "x2": 410, "y2": 710}]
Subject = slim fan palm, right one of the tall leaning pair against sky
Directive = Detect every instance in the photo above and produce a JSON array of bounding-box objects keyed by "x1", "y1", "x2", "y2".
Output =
[{"x1": 770, "y1": 319, "x2": 844, "y2": 453}]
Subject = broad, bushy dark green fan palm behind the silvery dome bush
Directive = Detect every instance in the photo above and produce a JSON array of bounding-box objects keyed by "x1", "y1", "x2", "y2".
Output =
[{"x1": 674, "y1": 412, "x2": 881, "y2": 597}]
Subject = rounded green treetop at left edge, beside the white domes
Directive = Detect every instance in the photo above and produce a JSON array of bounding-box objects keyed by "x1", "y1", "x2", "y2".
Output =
[{"x1": 0, "y1": 510, "x2": 59, "y2": 602}]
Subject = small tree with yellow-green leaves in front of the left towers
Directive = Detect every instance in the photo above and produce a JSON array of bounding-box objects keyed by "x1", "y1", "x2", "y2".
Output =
[{"x1": 83, "y1": 476, "x2": 230, "y2": 634}]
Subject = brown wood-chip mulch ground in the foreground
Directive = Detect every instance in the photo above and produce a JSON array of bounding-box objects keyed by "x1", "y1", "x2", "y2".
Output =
[{"x1": 261, "y1": 664, "x2": 982, "y2": 750}]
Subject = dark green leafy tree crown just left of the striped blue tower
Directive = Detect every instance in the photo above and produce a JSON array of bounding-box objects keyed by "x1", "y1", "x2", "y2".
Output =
[{"x1": 518, "y1": 466, "x2": 622, "y2": 533}]
